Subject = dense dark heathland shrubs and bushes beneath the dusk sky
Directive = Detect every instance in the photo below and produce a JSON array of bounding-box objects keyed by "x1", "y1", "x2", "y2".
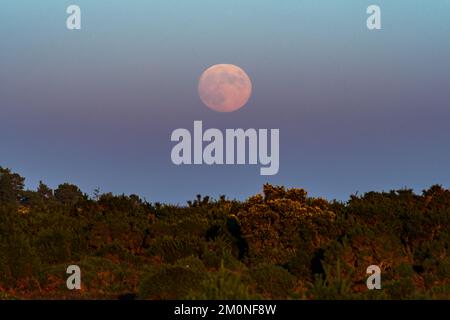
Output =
[{"x1": 0, "y1": 167, "x2": 450, "y2": 299}]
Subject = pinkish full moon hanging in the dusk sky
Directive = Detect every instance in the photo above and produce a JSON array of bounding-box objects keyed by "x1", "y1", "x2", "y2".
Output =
[{"x1": 198, "y1": 64, "x2": 252, "y2": 112}]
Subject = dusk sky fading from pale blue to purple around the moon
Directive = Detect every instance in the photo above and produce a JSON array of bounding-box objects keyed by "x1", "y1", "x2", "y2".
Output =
[{"x1": 0, "y1": 0, "x2": 450, "y2": 204}]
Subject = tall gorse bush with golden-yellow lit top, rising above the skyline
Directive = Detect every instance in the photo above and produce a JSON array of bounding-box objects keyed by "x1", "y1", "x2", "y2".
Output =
[{"x1": 238, "y1": 184, "x2": 334, "y2": 264}]
